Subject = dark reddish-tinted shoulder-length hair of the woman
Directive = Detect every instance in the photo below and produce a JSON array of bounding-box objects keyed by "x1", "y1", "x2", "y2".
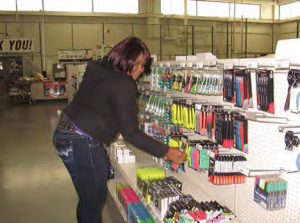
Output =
[{"x1": 107, "y1": 36, "x2": 151, "y2": 73}]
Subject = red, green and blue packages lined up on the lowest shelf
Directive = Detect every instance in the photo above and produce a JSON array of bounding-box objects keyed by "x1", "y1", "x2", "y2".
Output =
[{"x1": 116, "y1": 183, "x2": 156, "y2": 223}]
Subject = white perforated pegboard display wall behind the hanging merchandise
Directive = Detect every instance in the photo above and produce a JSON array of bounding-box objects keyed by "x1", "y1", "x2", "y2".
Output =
[{"x1": 147, "y1": 59, "x2": 300, "y2": 223}]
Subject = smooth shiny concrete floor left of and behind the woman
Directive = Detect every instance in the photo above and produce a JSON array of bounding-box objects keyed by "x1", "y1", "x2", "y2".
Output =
[{"x1": 0, "y1": 101, "x2": 123, "y2": 223}]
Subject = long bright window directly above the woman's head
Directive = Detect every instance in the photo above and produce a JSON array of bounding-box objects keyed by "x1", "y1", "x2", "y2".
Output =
[{"x1": 94, "y1": 0, "x2": 139, "y2": 13}]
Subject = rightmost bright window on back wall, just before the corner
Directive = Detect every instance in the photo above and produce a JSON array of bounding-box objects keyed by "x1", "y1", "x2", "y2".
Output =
[{"x1": 230, "y1": 3, "x2": 260, "y2": 19}]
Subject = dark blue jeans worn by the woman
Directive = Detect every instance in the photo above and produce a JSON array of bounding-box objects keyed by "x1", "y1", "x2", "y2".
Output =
[{"x1": 53, "y1": 128, "x2": 108, "y2": 223}]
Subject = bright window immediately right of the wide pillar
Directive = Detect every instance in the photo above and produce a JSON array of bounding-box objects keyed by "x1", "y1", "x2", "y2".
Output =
[{"x1": 161, "y1": 0, "x2": 184, "y2": 15}]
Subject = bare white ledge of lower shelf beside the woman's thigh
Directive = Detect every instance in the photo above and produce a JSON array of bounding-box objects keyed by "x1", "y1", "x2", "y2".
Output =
[{"x1": 111, "y1": 148, "x2": 163, "y2": 222}]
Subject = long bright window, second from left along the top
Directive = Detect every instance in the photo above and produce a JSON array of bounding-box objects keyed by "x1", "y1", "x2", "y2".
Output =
[{"x1": 44, "y1": 0, "x2": 92, "y2": 12}]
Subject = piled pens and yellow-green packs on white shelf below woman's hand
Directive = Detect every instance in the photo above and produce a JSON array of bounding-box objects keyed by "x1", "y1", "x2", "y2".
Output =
[{"x1": 137, "y1": 167, "x2": 235, "y2": 223}]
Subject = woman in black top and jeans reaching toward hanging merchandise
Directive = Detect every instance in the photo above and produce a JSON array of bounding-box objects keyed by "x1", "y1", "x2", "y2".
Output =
[{"x1": 54, "y1": 37, "x2": 186, "y2": 223}]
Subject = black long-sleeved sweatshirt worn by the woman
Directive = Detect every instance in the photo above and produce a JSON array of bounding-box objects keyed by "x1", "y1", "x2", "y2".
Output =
[{"x1": 64, "y1": 58, "x2": 168, "y2": 157}]
